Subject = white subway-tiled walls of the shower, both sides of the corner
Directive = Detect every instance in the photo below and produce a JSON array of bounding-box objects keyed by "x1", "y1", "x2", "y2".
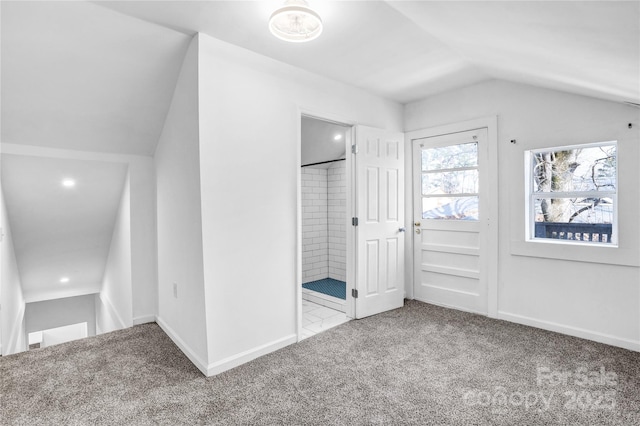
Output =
[{"x1": 302, "y1": 165, "x2": 347, "y2": 283}]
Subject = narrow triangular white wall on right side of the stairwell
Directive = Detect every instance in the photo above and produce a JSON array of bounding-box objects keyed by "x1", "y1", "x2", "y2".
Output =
[{"x1": 95, "y1": 176, "x2": 133, "y2": 333}]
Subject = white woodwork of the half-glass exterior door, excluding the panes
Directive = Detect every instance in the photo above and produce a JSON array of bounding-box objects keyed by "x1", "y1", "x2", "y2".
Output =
[{"x1": 411, "y1": 128, "x2": 490, "y2": 315}]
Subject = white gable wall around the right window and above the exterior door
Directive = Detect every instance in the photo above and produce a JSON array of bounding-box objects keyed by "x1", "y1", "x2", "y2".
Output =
[{"x1": 405, "y1": 81, "x2": 640, "y2": 350}]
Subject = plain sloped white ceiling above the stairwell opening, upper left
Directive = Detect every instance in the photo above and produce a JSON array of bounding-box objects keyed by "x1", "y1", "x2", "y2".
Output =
[{"x1": 1, "y1": 1, "x2": 190, "y2": 155}]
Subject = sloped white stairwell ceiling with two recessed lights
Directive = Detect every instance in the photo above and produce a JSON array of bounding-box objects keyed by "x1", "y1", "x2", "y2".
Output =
[{"x1": 1, "y1": 154, "x2": 127, "y2": 302}]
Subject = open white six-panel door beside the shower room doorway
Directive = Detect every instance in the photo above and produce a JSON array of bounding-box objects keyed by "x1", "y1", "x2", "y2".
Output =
[{"x1": 355, "y1": 126, "x2": 405, "y2": 318}]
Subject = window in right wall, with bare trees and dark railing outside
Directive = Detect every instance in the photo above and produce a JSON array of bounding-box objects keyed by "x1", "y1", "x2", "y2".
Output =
[{"x1": 526, "y1": 142, "x2": 617, "y2": 245}]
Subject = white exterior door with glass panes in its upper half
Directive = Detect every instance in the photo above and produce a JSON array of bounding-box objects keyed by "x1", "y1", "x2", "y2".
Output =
[{"x1": 412, "y1": 128, "x2": 488, "y2": 315}]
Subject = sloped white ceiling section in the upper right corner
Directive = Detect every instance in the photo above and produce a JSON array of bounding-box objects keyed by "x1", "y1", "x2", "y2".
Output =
[{"x1": 390, "y1": 1, "x2": 640, "y2": 103}]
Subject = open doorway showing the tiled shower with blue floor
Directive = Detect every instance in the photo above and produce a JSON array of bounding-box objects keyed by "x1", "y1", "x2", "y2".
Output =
[{"x1": 299, "y1": 115, "x2": 352, "y2": 338}]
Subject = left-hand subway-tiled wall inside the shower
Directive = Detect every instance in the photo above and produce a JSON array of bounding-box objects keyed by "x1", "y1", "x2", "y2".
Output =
[{"x1": 301, "y1": 167, "x2": 329, "y2": 283}]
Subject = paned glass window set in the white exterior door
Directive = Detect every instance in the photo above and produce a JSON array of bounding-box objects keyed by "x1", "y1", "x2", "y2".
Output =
[{"x1": 421, "y1": 142, "x2": 478, "y2": 220}]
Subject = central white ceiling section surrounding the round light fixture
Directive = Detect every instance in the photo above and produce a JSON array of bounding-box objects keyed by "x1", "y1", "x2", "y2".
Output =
[{"x1": 94, "y1": 0, "x2": 488, "y2": 102}]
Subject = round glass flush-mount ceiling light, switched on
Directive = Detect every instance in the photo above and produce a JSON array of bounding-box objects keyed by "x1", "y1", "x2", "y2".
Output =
[{"x1": 269, "y1": 0, "x2": 322, "y2": 43}]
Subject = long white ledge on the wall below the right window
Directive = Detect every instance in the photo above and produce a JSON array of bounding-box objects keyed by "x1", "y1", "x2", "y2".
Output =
[{"x1": 510, "y1": 240, "x2": 640, "y2": 266}]
